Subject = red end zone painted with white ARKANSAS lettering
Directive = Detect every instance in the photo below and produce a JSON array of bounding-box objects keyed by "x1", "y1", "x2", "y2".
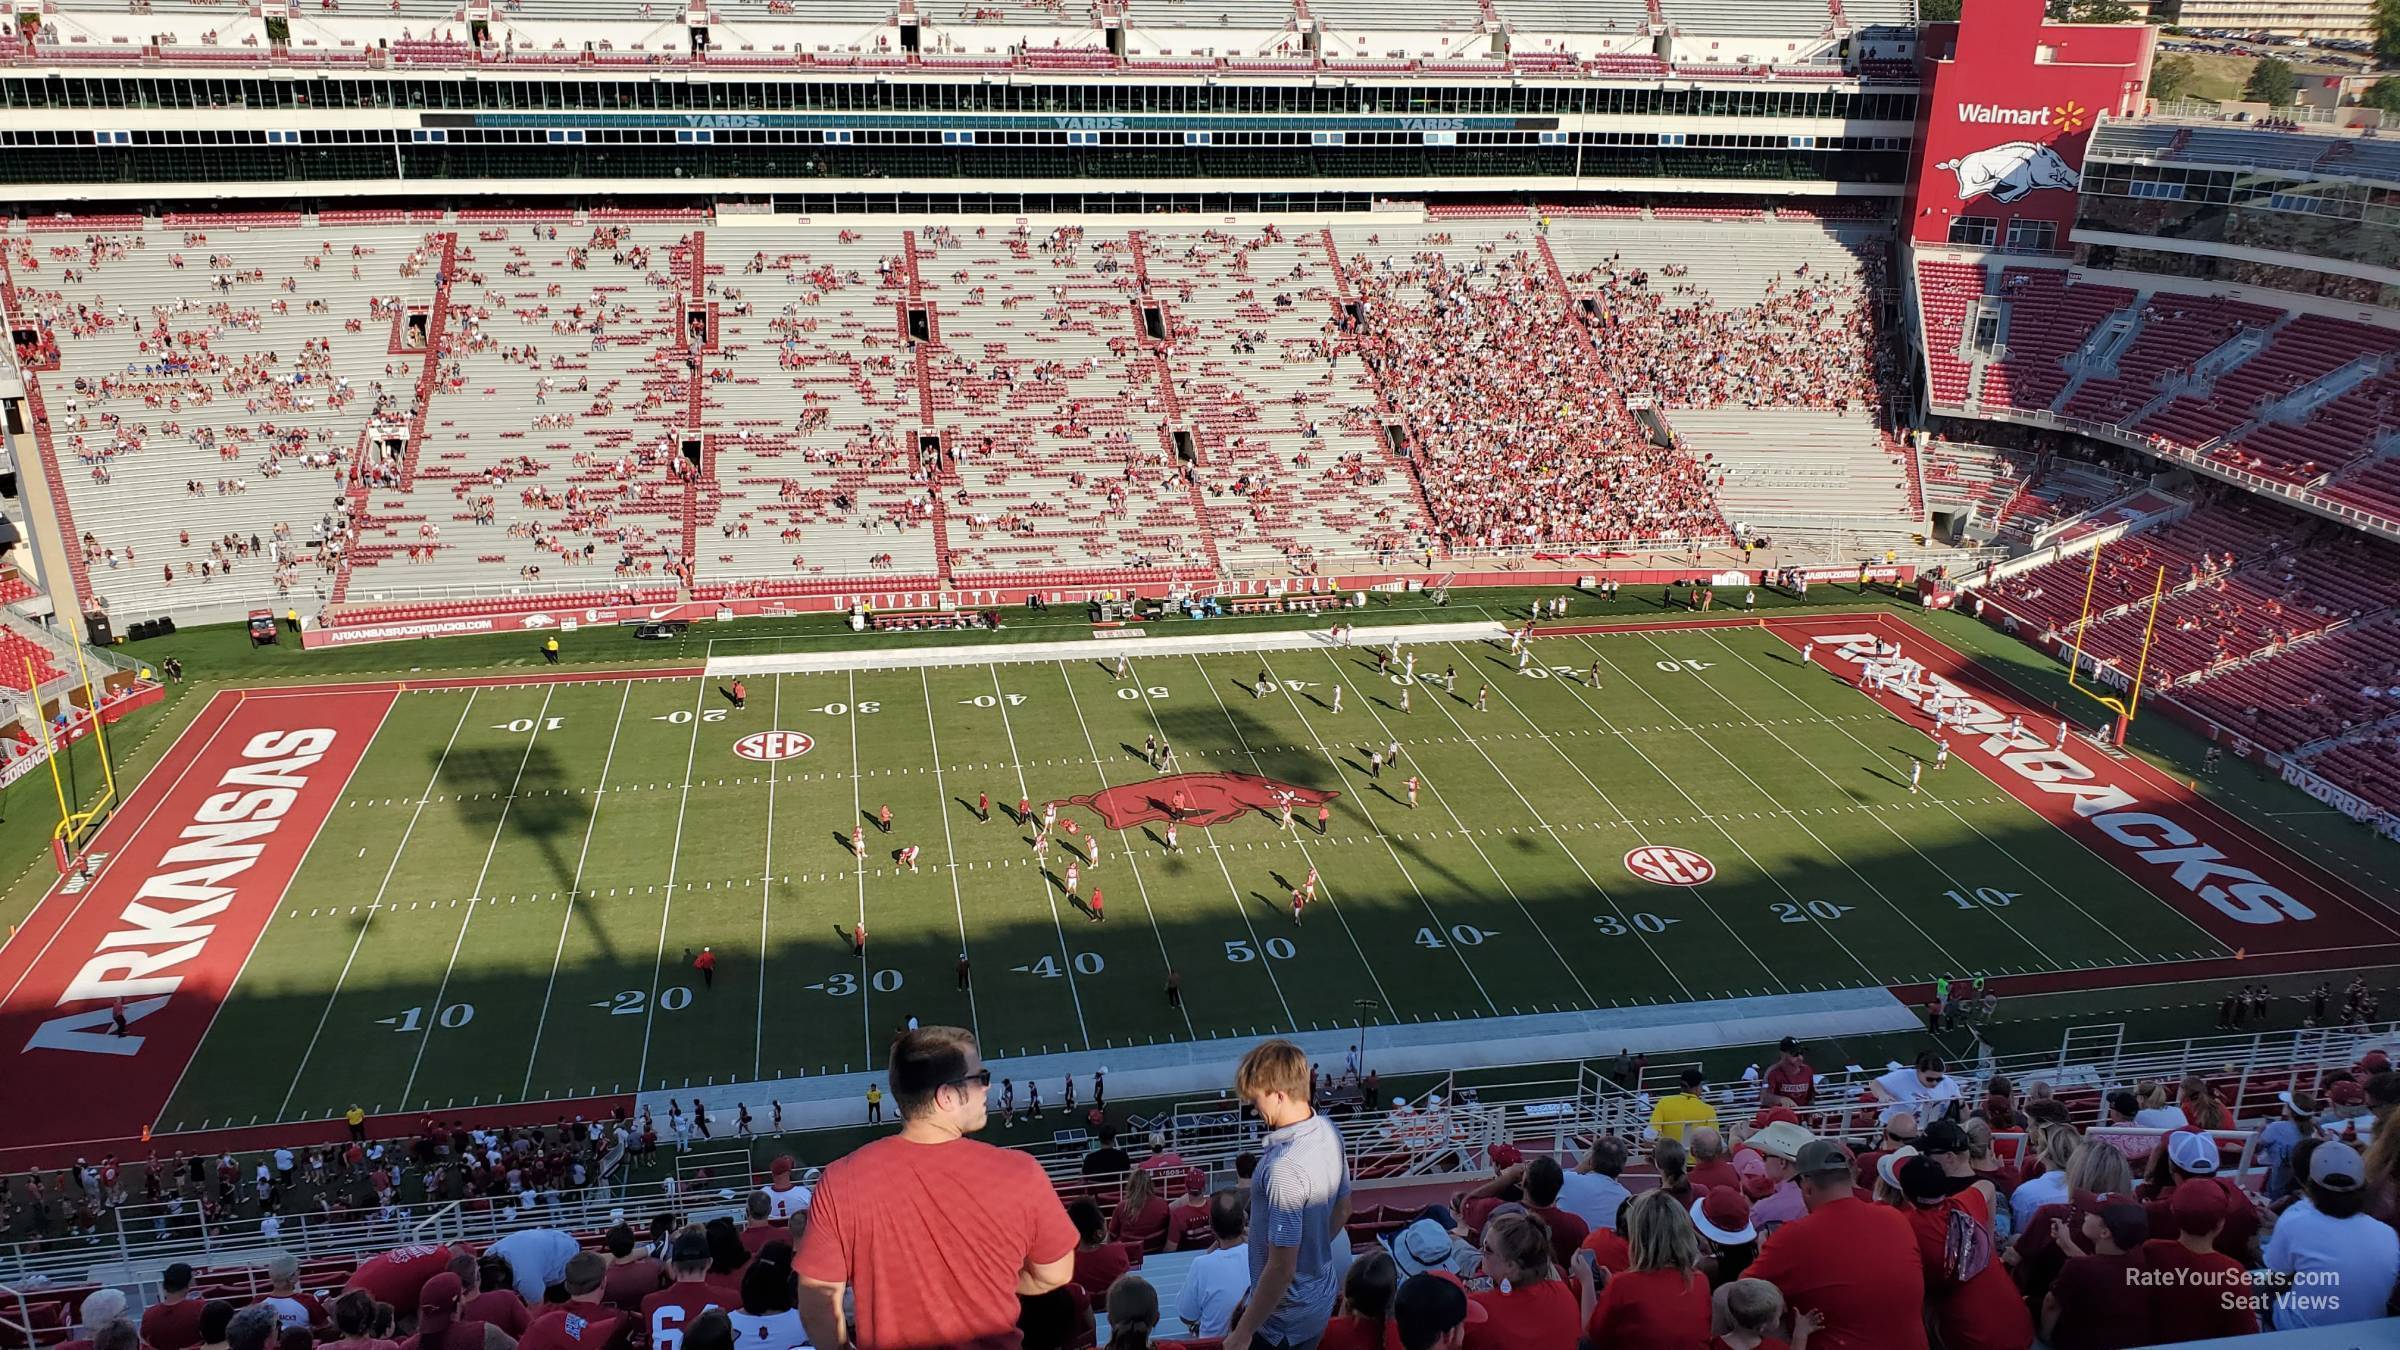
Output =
[{"x1": 0, "y1": 685, "x2": 398, "y2": 1153}]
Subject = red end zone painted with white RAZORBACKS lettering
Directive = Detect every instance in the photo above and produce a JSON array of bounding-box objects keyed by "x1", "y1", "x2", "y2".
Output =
[{"x1": 1766, "y1": 615, "x2": 2400, "y2": 992}]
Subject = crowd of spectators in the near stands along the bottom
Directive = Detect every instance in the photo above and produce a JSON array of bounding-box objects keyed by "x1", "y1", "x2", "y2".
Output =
[{"x1": 32, "y1": 1028, "x2": 2400, "y2": 1350}]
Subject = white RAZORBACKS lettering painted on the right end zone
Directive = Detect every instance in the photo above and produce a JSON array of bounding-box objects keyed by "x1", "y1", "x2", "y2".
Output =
[{"x1": 1810, "y1": 634, "x2": 2316, "y2": 925}]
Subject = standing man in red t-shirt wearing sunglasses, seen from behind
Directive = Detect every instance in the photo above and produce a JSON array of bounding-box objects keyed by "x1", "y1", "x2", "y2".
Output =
[{"x1": 794, "y1": 1026, "x2": 1075, "y2": 1350}]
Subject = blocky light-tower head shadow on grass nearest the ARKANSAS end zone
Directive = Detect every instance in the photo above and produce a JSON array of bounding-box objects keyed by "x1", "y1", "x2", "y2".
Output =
[{"x1": 427, "y1": 737, "x2": 593, "y2": 908}]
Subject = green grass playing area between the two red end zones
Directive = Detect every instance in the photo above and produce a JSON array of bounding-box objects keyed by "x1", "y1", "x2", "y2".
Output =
[{"x1": 158, "y1": 614, "x2": 2222, "y2": 1131}]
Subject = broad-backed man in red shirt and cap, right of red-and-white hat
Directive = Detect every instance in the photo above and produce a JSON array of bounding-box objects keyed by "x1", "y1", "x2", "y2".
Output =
[{"x1": 1745, "y1": 1139, "x2": 1925, "y2": 1350}]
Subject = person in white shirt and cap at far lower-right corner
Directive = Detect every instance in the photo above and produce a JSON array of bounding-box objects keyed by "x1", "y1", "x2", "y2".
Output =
[{"x1": 2266, "y1": 1141, "x2": 2400, "y2": 1331}]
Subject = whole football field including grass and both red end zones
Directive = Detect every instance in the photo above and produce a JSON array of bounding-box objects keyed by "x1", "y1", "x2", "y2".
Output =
[{"x1": 0, "y1": 615, "x2": 2395, "y2": 1141}]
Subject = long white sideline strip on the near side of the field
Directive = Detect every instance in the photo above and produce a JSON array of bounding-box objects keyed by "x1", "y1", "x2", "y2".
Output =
[{"x1": 636, "y1": 987, "x2": 1925, "y2": 1129}]
